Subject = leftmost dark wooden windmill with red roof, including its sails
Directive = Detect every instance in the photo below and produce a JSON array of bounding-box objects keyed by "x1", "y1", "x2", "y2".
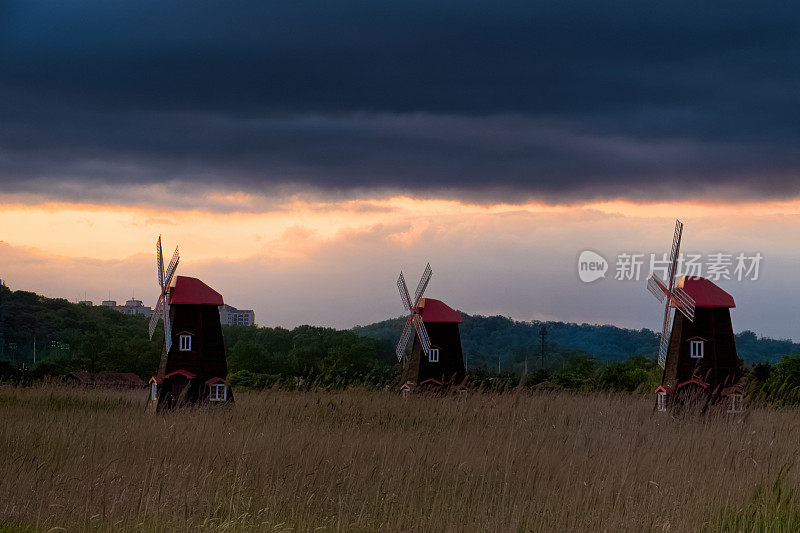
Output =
[{"x1": 148, "y1": 237, "x2": 233, "y2": 410}]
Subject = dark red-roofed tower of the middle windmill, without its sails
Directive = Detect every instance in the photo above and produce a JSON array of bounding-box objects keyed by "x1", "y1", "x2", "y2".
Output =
[{"x1": 403, "y1": 298, "x2": 466, "y2": 389}]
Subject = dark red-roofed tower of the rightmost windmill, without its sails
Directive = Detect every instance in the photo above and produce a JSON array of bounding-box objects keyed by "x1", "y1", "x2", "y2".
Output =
[{"x1": 656, "y1": 277, "x2": 743, "y2": 409}]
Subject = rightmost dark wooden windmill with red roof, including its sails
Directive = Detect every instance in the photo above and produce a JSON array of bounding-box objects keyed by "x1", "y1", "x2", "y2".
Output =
[{"x1": 647, "y1": 221, "x2": 742, "y2": 411}]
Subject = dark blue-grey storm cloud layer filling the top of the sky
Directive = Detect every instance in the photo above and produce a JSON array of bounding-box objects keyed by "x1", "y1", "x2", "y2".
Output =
[{"x1": 0, "y1": 0, "x2": 800, "y2": 201}]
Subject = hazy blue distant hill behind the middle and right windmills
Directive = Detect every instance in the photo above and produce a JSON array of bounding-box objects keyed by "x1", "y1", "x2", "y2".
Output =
[{"x1": 354, "y1": 312, "x2": 800, "y2": 370}]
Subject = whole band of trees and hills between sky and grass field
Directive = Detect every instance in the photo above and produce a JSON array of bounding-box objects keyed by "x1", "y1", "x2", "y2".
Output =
[{"x1": 0, "y1": 287, "x2": 800, "y2": 404}]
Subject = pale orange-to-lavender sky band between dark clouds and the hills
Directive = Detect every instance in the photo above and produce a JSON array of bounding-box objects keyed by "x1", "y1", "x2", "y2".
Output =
[{"x1": 0, "y1": 193, "x2": 800, "y2": 338}]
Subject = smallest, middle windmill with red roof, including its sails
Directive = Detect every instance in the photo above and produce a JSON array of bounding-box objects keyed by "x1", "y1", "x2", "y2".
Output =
[{"x1": 397, "y1": 264, "x2": 466, "y2": 388}]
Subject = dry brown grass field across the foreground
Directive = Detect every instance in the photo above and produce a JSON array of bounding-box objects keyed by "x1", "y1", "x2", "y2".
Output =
[{"x1": 0, "y1": 386, "x2": 800, "y2": 532}]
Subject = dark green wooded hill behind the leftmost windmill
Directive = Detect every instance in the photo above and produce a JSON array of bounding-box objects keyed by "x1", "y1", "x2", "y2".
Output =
[{"x1": 0, "y1": 286, "x2": 395, "y2": 386}]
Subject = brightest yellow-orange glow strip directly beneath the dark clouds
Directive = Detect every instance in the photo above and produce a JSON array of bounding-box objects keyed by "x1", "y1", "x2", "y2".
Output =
[{"x1": 6, "y1": 193, "x2": 800, "y2": 260}]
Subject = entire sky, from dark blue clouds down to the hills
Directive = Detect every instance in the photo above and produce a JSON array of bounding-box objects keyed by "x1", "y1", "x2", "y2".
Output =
[{"x1": 0, "y1": 0, "x2": 800, "y2": 340}]
